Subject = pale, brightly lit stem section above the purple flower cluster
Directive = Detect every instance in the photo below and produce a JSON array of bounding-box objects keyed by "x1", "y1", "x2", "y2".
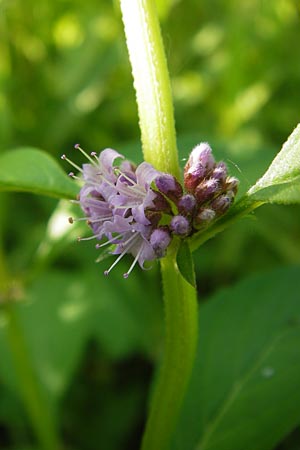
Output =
[{"x1": 120, "y1": 0, "x2": 180, "y2": 178}]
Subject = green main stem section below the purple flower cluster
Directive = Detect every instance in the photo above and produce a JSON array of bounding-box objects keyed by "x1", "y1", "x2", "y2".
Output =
[{"x1": 142, "y1": 246, "x2": 198, "y2": 450}]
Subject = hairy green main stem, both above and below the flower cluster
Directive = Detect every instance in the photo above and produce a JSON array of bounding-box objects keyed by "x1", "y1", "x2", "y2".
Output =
[{"x1": 120, "y1": 0, "x2": 198, "y2": 450}]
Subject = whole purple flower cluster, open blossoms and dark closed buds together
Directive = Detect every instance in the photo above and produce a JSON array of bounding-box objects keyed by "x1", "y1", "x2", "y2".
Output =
[{"x1": 62, "y1": 144, "x2": 238, "y2": 278}]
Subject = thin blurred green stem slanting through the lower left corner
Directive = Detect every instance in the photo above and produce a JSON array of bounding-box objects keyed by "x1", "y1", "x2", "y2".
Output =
[{"x1": 4, "y1": 303, "x2": 61, "y2": 450}]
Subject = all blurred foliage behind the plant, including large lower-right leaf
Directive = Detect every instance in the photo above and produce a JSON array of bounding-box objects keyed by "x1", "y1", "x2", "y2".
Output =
[{"x1": 0, "y1": 0, "x2": 300, "y2": 450}]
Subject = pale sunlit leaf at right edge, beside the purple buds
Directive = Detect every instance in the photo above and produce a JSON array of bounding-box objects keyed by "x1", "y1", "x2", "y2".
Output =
[{"x1": 248, "y1": 124, "x2": 300, "y2": 204}]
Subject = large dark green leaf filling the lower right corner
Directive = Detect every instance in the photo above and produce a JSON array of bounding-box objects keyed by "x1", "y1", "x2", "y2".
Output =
[{"x1": 172, "y1": 266, "x2": 300, "y2": 450}]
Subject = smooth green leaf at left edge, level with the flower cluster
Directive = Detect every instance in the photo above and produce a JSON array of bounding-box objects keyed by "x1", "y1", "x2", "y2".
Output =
[{"x1": 0, "y1": 147, "x2": 79, "y2": 198}]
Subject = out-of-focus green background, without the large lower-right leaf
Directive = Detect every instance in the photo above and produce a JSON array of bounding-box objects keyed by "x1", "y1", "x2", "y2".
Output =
[{"x1": 0, "y1": 0, "x2": 300, "y2": 450}]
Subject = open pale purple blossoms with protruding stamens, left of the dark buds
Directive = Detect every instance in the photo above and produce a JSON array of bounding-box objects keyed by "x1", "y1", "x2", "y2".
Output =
[{"x1": 67, "y1": 146, "x2": 171, "y2": 278}]
